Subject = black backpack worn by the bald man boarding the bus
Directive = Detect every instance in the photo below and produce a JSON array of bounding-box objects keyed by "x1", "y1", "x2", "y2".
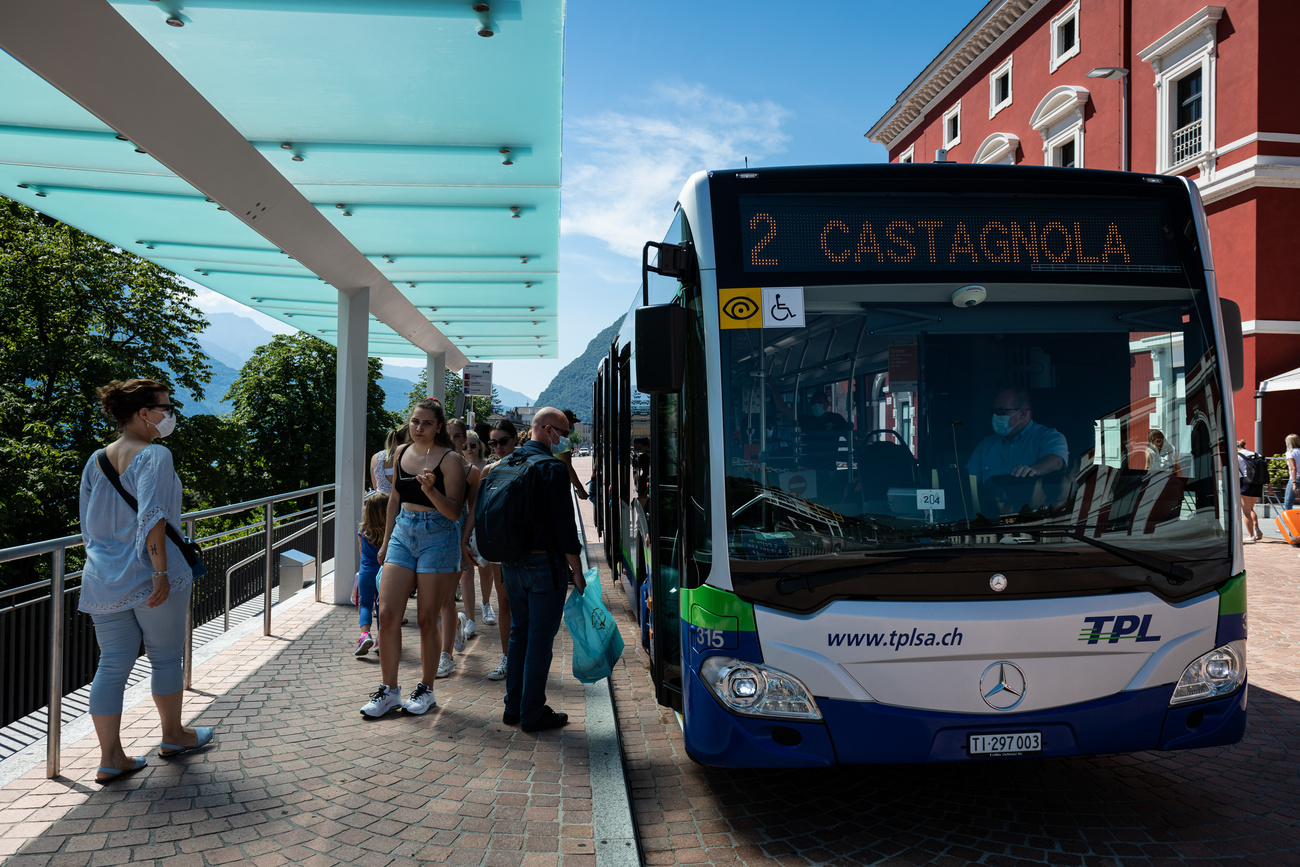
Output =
[{"x1": 475, "y1": 451, "x2": 555, "y2": 563}]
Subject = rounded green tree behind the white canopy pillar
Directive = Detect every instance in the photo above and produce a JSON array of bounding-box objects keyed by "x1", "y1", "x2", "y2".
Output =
[{"x1": 225, "y1": 331, "x2": 393, "y2": 497}]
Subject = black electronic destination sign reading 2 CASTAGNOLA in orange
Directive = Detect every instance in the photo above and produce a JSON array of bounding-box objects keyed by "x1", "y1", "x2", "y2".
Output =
[{"x1": 740, "y1": 195, "x2": 1182, "y2": 279}]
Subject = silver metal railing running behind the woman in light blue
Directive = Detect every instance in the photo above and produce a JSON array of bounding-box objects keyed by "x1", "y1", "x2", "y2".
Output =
[{"x1": 0, "y1": 485, "x2": 334, "y2": 777}]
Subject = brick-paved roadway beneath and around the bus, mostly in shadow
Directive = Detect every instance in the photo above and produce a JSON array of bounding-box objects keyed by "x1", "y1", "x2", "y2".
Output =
[{"x1": 600, "y1": 514, "x2": 1300, "y2": 867}]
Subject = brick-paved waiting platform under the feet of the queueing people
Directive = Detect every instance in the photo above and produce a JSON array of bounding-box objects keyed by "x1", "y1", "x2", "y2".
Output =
[{"x1": 0, "y1": 569, "x2": 595, "y2": 867}]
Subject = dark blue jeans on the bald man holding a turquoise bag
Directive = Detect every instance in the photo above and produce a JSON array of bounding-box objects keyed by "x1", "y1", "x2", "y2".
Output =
[{"x1": 501, "y1": 554, "x2": 568, "y2": 723}]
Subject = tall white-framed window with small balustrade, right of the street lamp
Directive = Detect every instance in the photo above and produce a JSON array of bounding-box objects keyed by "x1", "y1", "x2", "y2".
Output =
[{"x1": 1138, "y1": 6, "x2": 1223, "y2": 175}]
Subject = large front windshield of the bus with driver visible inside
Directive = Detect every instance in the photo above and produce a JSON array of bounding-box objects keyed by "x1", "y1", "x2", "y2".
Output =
[{"x1": 720, "y1": 282, "x2": 1235, "y2": 595}]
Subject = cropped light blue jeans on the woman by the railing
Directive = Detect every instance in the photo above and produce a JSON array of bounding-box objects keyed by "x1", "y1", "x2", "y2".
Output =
[{"x1": 90, "y1": 588, "x2": 191, "y2": 716}]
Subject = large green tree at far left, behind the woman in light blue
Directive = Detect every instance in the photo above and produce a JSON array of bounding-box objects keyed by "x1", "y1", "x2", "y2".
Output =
[{"x1": 0, "y1": 198, "x2": 211, "y2": 546}]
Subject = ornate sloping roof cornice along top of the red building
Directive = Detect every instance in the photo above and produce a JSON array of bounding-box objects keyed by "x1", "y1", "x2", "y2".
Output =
[{"x1": 866, "y1": 0, "x2": 1048, "y2": 147}]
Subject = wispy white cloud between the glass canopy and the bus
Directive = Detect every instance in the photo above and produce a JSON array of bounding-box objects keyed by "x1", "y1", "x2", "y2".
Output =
[{"x1": 560, "y1": 84, "x2": 789, "y2": 260}]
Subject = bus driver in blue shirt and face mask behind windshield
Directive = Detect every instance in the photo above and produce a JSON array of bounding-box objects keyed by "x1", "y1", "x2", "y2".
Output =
[{"x1": 966, "y1": 389, "x2": 1070, "y2": 482}]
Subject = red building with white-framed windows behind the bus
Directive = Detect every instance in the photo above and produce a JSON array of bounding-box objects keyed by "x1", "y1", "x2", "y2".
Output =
[{"x1": 867, "y1": 0, "x2": 1300, "y2": 454}]
